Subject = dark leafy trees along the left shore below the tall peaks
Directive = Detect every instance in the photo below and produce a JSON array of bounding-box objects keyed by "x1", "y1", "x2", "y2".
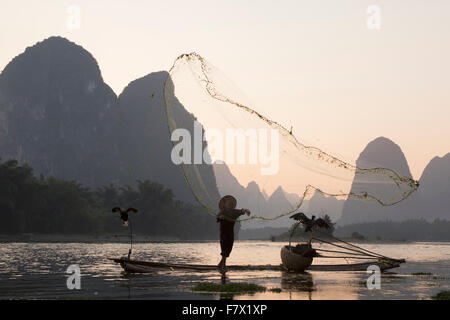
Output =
[{"x1": 0, "y1": 160, "x2": 218, "y2": 239}]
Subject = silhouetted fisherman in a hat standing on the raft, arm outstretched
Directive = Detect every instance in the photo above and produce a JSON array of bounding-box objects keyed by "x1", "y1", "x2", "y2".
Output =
[{"x1": 217, "y1": 195, "x2": 250, "y2": 273}]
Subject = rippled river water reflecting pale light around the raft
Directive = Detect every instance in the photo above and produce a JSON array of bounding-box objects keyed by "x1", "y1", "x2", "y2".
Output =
[{"x1": 0, "y1": 241, "x2": 450, "y2": 300}]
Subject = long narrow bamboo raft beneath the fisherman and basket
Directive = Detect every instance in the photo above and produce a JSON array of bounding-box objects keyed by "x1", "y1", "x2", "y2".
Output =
[{"x1": 109, "y1": 257, "x2": 405, "y2": 273}]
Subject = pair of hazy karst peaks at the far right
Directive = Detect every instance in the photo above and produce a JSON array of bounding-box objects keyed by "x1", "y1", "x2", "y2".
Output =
[{"x1": 339, "y1": 137, "x2": 450, "y2": 225}]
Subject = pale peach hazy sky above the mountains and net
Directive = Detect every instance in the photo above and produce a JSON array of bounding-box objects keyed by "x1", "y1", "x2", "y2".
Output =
[{"x1": 0, "y1": 0, "x2": 450, "y2": 179}]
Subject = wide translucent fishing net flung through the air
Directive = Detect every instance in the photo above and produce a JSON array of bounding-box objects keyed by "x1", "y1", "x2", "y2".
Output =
[{"x1": 164, "y1": 53, "x2": 418, "y2": 228}]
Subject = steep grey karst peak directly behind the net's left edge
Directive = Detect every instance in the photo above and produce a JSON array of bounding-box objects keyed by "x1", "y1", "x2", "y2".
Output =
[{"x1": 117, "y1": 71, "x2": 219, "y2": 202}]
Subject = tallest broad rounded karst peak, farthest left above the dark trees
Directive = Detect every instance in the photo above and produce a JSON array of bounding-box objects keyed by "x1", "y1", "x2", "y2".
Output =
[{"x1": 0, "y1": 37, "x2": 119, "y2": 185}]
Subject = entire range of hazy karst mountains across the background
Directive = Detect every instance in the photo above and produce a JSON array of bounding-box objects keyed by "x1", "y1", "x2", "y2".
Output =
[{"x1": 0, "y1": 37, "x2": 450, "y2": 228}]
